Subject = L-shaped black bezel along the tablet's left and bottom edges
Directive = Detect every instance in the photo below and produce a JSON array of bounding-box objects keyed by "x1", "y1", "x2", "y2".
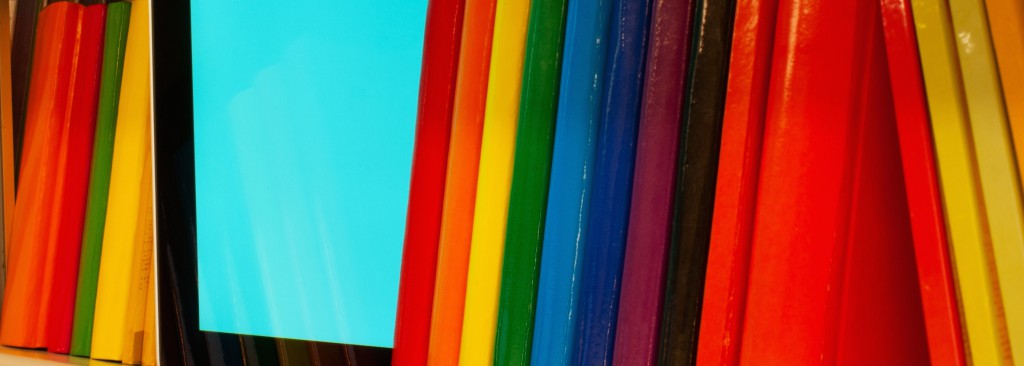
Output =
[{"x1": 150, "y1": 0, "x2": 391, "y2": 365}]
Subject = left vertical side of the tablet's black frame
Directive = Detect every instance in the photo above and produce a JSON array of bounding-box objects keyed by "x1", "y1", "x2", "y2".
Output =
[{"x1": 150, "y1": 0, "x2": 209, "y2": 358}]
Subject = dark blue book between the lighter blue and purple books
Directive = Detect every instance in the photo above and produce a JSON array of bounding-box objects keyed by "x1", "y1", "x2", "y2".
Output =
[{"x1": 574, "y1": 0, "x2": 650, "y2": 365}]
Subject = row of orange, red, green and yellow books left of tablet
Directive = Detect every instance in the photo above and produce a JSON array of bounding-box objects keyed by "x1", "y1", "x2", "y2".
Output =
[{"x1": 0, "y1": 0, "x2": 156, "y2": 364}]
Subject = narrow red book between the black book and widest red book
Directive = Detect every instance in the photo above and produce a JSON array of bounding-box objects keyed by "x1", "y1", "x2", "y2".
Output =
[{"x1": 697, "y1": 0, "x2": 778, "y2": 365}]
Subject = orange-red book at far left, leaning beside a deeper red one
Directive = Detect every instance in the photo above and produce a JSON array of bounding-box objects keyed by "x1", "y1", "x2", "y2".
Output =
[{"x1": 0, "y1": 2, "x2": 84, "y2": 348}]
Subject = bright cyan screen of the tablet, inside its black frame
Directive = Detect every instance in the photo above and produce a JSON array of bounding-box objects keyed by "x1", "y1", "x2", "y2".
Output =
[{"x1": 191, "y1": 0, "x2": 427, "y2": 347}]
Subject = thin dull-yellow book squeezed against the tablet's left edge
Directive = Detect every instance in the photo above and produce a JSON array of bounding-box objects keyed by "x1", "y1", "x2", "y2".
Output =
[{"x1": 121, "y1": 150, "x2": 153, "y2": 365}]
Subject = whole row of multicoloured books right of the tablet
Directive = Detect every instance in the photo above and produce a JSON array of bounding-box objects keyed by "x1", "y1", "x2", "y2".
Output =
[{"x1": 393, "y1": 0, "x2": 1024, "y2": 366}]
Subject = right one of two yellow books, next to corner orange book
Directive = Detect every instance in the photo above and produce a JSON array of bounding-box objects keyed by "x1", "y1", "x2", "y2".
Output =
[{"x1": 949, "y1": 0, "x2": 1024, "y2": 358}]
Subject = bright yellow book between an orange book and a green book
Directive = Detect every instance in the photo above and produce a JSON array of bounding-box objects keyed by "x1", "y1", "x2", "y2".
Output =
[{"x1": 459, "y1": 0, "x2": 529, "y2": 365}]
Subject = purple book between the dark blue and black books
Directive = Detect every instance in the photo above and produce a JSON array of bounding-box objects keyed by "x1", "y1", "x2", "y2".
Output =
[{"x1": 614, "y1": 0, "x2": 693, "y2": 360}]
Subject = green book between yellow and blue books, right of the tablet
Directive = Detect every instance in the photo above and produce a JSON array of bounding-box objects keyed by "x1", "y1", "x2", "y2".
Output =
[{"x1": 495, "y1": 0, "x2": 566, "y2": 365}]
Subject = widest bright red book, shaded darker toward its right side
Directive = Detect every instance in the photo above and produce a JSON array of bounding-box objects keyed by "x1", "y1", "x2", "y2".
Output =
[{"x1": 740, "y1": 0, "x2": 929, "y2": 365}]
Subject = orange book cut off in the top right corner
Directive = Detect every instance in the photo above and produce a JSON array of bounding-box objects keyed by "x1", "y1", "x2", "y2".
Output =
[{"x1": 985, "y1": 0, "x2": 1024, "y2": 183}]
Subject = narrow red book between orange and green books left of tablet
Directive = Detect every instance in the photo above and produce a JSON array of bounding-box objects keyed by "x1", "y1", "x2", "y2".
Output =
[{"x1": 47, "y1": 4, "x2": 106, "y2": 354}]
